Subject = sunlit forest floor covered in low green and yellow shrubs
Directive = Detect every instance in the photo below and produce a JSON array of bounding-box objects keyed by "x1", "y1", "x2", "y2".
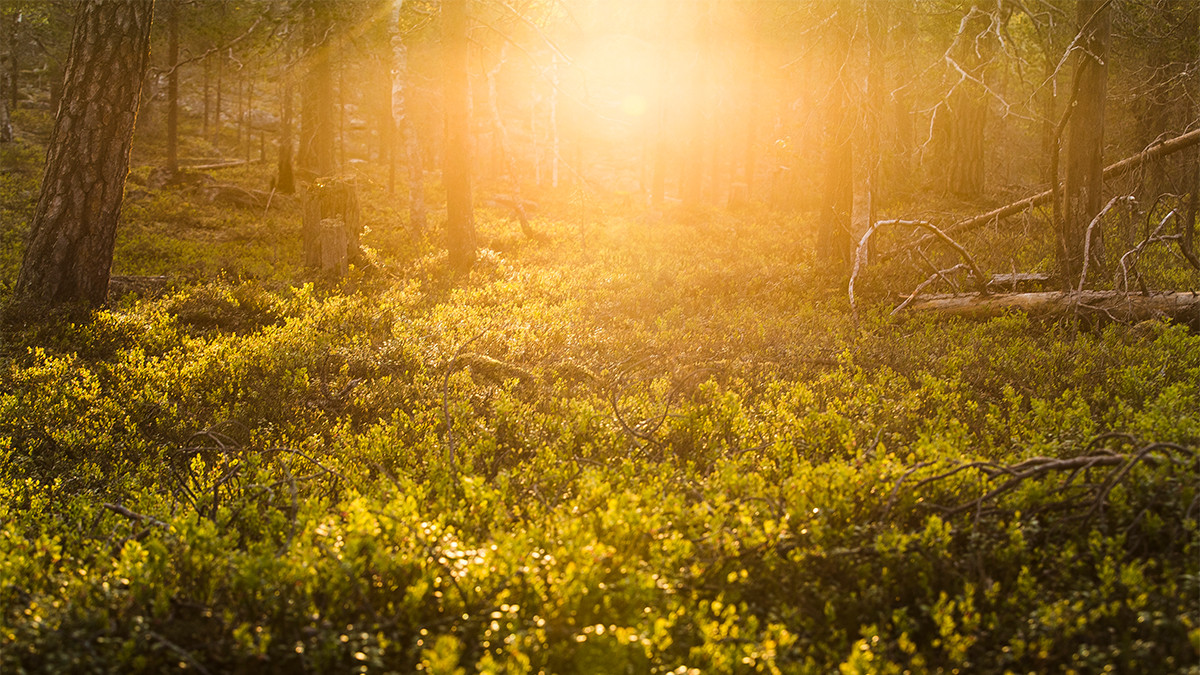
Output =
[{"x1": 0, "y1": 109, "x2": 1200, "y2": 674}]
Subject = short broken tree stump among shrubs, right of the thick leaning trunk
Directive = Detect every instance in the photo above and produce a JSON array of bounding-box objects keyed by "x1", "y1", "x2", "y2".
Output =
[{"x1": 304, "y1": 179, "x2": 362, "y2": 274}]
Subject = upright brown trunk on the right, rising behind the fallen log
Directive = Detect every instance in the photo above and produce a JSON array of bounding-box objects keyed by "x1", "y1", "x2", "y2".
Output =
[{"x1": 1058, "y1": 0, "x2": 1110, "y2": 287}]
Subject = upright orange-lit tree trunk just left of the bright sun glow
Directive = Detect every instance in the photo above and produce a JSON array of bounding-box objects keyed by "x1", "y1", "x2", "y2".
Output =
[{"x1": 442, "y1": 0, "x2": 475, "y2": 271}]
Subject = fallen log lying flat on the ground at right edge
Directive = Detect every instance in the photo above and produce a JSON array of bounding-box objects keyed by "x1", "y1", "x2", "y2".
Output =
[{"x1": 907, "y1": 291, "x2": 1200, "y2": 329}]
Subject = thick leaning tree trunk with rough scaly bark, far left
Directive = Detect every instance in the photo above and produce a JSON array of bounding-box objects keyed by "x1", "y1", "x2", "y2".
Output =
[{"x1": 16, "y1": 0, "x2": 154, "y2": 305}]
